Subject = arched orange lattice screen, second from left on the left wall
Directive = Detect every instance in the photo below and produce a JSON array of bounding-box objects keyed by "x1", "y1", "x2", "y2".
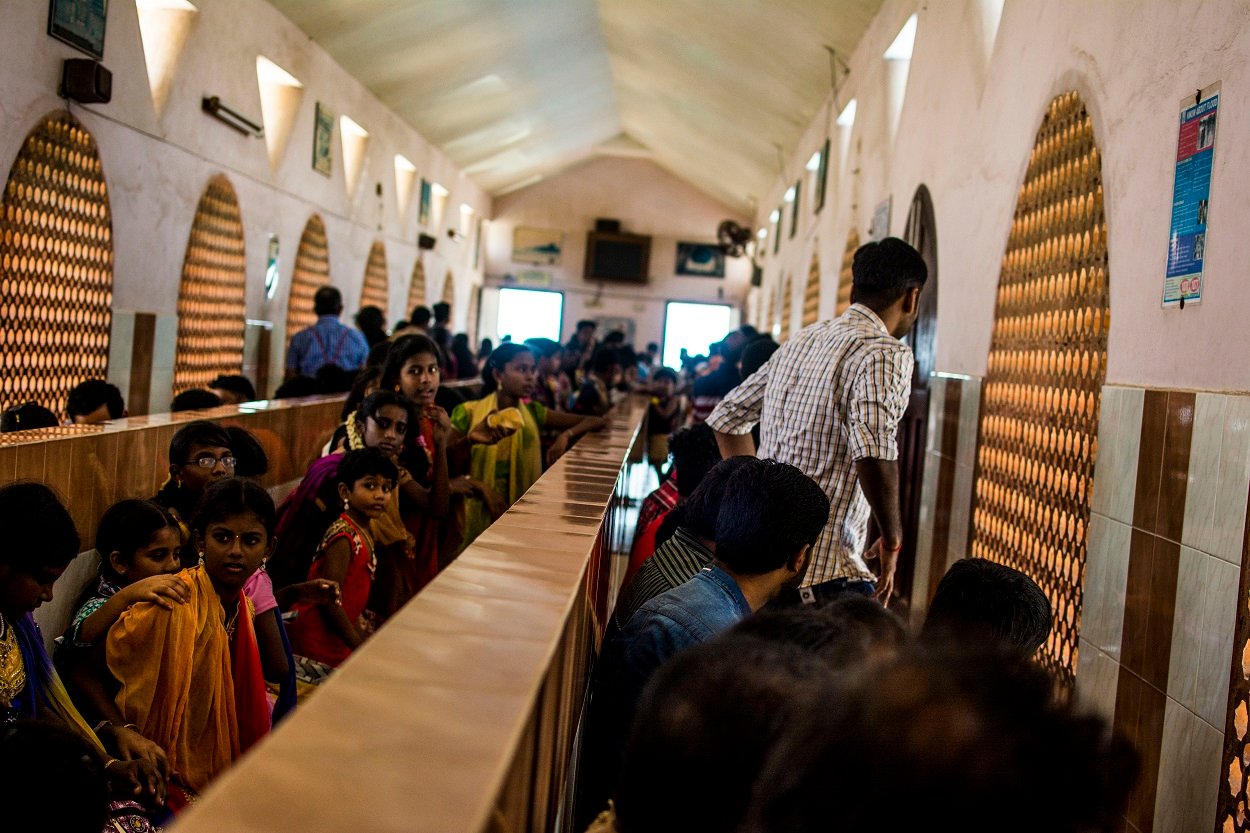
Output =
[{"x1": 174, "y1": 175, "x2": 248, "y2": 395}]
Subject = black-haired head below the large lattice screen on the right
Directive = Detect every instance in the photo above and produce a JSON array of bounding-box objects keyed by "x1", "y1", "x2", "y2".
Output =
[{"x1": 924, "y1": 558, "x2": 1051, "y2": 654}]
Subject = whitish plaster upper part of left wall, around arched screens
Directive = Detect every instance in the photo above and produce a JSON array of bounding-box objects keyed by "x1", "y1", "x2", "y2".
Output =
[{"x1": 0, "y1": 0, "x2": 491, "y2": 402}]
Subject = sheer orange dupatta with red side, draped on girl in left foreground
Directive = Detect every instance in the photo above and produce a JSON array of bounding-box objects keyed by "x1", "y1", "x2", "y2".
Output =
[{"x1": 106, "y1": 567, "x2": 269, "y2": 792}]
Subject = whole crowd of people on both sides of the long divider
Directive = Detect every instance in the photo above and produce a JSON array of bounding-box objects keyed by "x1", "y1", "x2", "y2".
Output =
[{"x1": 0, "y1": 238, "x2": 1139, "y2": 833}]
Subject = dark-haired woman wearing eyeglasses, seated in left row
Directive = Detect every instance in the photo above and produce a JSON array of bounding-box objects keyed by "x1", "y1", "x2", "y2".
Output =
[{"x1": 153, "y1": 419, "x2": 235, "y2": 567}]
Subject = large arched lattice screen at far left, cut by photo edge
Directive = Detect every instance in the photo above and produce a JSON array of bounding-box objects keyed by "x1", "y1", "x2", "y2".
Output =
[{"x1": 0, "y1": 114, "x2": 113, "y2": 413}]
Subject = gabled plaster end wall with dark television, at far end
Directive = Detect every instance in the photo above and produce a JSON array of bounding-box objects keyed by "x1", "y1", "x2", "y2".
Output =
[{"x1": 482, "y1": 158, "x2": 751, "y2": 346}]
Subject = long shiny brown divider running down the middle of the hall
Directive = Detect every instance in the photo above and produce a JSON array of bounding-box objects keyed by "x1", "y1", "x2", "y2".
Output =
[{"x1": 174, "y1": 396, "x2": 646, "y2": 833}]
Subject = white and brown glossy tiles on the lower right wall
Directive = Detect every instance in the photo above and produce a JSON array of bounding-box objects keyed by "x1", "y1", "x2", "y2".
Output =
[{"x1": 913, "y1": 376, "x2": 1250, "y2": 833}]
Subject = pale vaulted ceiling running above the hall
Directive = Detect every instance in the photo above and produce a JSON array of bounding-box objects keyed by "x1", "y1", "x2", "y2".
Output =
[{"x1": 270, "y1": 0, "x2": 881, "y2": 215}]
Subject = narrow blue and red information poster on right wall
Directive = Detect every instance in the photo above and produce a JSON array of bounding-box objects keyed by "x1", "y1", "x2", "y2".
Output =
[{"x1": 1164, "y1": 84, "x2": 1220, "y2": 308}]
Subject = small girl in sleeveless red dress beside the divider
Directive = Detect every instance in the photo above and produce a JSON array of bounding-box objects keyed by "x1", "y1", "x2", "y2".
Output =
[{"x1": 288, "y1": 448, "x2": 398, "y2": 683}]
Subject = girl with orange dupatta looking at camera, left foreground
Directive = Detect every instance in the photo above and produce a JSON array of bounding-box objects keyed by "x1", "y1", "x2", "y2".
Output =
[{"x1": 106, "y1": 478, "x2": 275, "y2": 812}]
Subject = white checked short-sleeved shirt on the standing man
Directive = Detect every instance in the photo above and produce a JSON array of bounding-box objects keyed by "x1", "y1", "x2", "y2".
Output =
[{"x1": 708, "y1": 304, "x2": 913, "y2": 587}]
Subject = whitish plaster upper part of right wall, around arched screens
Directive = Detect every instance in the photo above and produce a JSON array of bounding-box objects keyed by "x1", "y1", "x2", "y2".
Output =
[{"x1": 756, "y1": 0, "x2": 1250, "y2": 390}]
